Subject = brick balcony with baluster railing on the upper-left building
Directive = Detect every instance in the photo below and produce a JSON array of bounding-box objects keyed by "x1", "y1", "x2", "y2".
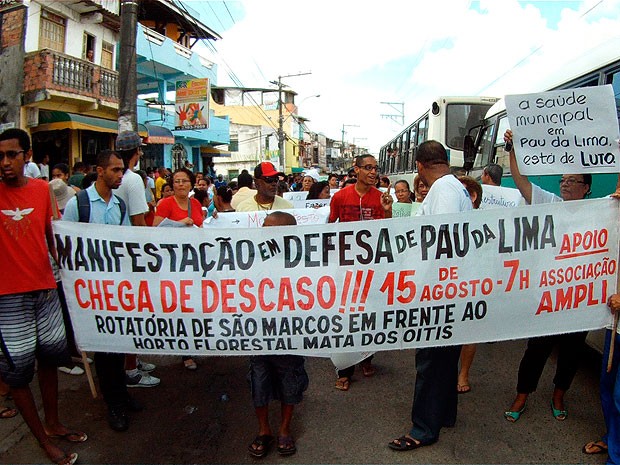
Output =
[{"x1": 24, "y1": 49, "x2": 118, "y2": 107}]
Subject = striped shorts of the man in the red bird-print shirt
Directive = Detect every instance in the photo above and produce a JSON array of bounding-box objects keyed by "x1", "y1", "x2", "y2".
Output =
[{"x1": 0, "y1": 289, "x2": 70, "y2": 387}]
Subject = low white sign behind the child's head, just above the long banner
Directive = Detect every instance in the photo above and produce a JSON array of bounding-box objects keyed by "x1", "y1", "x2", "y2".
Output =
[{"x1": 202, "y1": 208, "x2": 329, "y2": 228}]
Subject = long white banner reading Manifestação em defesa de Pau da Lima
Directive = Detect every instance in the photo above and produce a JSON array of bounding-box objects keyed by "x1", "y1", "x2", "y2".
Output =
[{"x1": 54, "y1": 199, "x2": 620, "y2": 356}]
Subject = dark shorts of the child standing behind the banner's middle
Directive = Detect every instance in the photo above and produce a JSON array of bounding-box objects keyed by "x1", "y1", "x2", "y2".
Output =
[{"x1": 248, "y1": 355, "x2": 308, "y2": 407}]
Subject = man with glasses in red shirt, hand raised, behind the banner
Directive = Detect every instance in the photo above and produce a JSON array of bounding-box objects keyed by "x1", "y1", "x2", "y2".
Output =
[{"x1": 329, "y1": 154, "x2": 393, "y2": 391}]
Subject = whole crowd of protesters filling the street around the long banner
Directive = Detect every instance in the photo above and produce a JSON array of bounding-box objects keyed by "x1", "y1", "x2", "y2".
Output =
[{"x1": 0, "y1": 129, "x2": 620, "y2": 465}]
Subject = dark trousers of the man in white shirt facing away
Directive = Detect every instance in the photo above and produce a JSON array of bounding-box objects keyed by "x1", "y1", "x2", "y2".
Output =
[{"x1": 409, "y1": 346, "x2": 461, "y2": 445}]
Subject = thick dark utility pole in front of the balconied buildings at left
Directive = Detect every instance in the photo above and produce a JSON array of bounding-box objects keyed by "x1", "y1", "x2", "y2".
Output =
[{"x1": 118, "y1": 0, "x2": 138, "y2": 132}]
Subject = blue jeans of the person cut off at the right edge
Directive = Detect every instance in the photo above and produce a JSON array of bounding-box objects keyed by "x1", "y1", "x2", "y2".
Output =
[{"x1": 600, "y1": 329, "x2": 620, "y2": 465}]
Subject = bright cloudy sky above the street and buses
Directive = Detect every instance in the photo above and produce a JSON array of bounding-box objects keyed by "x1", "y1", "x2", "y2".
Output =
[{"x1": 183, "y1": 0, "x2": 620, "y2": 154}]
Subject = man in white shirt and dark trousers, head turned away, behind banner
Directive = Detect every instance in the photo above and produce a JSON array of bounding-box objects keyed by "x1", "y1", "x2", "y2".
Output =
[{"x1": 388, "y1": 140, "x2": 473, "y2": 451}]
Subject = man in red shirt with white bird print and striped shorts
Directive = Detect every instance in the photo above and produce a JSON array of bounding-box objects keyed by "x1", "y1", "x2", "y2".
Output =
[{"x1": 0, "y1": 129, "x2": 87, "y2": 465}]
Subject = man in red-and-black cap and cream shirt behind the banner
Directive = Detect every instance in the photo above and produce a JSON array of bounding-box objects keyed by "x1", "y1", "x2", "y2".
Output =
[{"x1": 237, "y1": 161, "x2": 293, "y2": 212}]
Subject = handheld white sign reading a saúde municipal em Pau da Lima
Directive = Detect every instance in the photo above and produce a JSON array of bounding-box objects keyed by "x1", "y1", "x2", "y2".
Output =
[{"x1": 505, "y1": 85, "x2": 620, "y2": 175}]
